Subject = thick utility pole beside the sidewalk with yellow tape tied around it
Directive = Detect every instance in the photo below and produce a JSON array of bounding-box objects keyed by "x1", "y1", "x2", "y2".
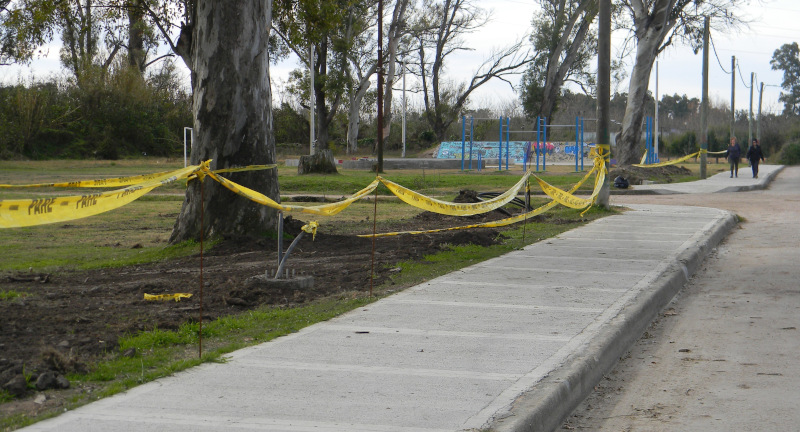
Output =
[{"x1": 597, "y1": 0, "x2": 611, "y2": 208}]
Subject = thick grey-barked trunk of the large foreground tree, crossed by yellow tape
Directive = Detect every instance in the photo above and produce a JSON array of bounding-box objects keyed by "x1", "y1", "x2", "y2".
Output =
[{"x1": 170, "y1": 0, "x2": 279, "y2": 243}]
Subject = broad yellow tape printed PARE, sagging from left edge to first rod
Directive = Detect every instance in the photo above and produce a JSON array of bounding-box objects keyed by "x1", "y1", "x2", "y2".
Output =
[{"x1": 0, "y1": 162, "x2": 208, "y2": 228}]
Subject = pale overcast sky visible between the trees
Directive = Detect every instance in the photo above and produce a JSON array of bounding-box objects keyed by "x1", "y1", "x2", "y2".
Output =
[{"x1": 0, "y1": 0, "x2": 800, "y2": 112}]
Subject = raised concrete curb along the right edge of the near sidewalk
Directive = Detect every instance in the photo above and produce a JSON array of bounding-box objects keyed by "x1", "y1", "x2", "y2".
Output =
[{"x1": 490, "y1": 208, "x2": 738, "y2": 432}]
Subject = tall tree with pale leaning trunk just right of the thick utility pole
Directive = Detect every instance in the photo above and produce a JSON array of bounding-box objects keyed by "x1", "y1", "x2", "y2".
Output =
[{"x1": 615, "y1": 0, "x2": 746, "y2": 165}]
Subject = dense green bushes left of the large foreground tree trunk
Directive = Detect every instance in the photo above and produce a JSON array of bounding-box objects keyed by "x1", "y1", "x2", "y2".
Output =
[{"x1": 0, "y1": 62, "x2": 192, "y2": 159}]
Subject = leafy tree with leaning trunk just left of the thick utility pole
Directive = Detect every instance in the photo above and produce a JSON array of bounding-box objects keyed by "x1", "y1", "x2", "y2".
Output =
[{"x1": 522, "y1": 0, "x2": 598, "y2": 119}]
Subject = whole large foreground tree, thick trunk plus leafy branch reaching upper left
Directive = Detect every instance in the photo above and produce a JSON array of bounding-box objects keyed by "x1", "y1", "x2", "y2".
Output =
[{"x1": 0, "y1": 0, "x2": 280, "y2": 242}]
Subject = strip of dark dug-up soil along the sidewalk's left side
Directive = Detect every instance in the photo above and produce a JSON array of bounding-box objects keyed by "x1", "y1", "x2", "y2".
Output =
[{"x1": 0, "y1": 209, "x2": 521, "y2": 418}]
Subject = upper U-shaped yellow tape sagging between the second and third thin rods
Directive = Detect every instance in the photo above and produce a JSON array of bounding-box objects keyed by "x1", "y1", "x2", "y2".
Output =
[{"x1": 380, "y1": 172, "x2": 531, "y2": 216}]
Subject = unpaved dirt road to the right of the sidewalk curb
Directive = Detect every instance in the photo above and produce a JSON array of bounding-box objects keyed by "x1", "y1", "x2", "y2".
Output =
[{"x1": 562, "y1": 167, "x2": 800, "y2": 431}]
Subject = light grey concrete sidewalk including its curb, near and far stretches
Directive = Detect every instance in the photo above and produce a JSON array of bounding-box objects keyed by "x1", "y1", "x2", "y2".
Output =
[{"x1": 23, "y1": 165, "x2": 780, "y2": 432}]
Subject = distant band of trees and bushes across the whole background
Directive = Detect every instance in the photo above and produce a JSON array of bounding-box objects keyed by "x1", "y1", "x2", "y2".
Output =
[{"x1": 0, "y1": 70, "x2": 800, "y2": 159}]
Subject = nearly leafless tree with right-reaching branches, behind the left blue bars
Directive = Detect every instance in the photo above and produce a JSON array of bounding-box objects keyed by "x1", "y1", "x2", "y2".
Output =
[{"x1": 412, "y1": 0, "x2": 532, "y2": 140}]
